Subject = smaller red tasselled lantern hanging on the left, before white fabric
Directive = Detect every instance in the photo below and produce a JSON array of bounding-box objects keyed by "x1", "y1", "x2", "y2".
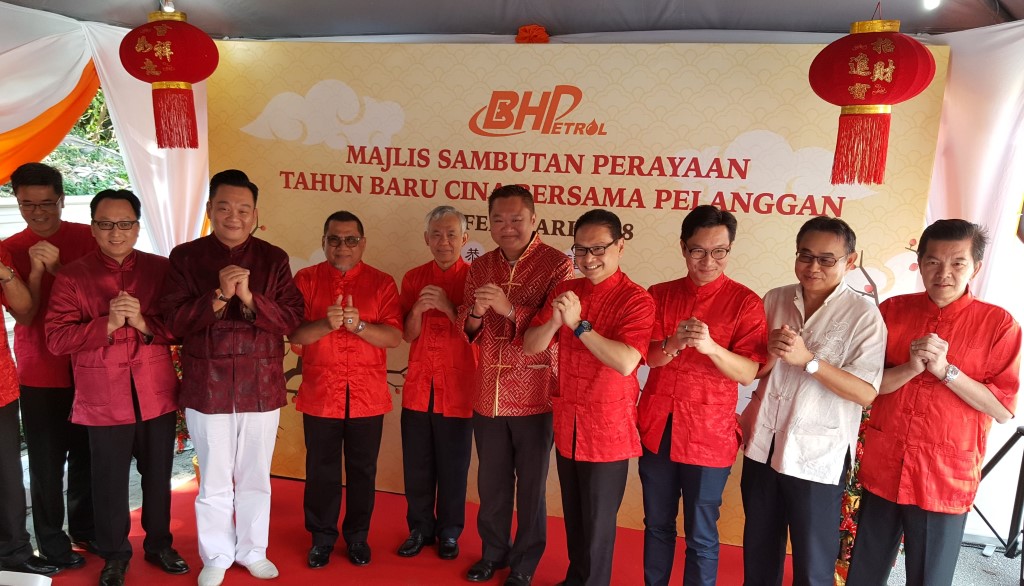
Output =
[{"x1": 120, "y1": 12, "x2": 219, "y2": 149}]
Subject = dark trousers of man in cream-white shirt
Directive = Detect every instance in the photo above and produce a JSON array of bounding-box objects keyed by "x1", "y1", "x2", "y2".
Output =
[{"x1": 739, "y1": 454, "x2": 850, "y2": 586}]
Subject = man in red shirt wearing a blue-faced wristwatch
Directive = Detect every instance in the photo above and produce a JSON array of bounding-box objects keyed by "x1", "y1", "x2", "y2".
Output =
[{"x1": 523, "y1": 210, "x2": 654, "y2": 586}]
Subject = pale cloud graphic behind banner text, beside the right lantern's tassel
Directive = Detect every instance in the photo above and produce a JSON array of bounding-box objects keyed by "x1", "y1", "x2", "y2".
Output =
[{"x1": 676, "y1": 130, "x2": 876, "y2": 200}]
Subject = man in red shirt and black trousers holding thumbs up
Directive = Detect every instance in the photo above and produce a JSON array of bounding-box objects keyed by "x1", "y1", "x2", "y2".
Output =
[{"x1": 289, "y1": 211, "x2": 401, "y2": 568}]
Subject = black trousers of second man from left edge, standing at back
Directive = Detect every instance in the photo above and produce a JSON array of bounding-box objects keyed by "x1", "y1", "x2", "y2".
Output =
[{"x1": 22, "y1": 386, "x2": 95, "y2": 557}]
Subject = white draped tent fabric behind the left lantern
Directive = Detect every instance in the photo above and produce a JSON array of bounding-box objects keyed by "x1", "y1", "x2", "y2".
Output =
[{"x1": 0, "y1": 3, "x2": 209, "y2": 254}]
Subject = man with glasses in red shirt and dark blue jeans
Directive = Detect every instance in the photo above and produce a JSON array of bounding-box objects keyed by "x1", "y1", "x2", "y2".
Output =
[{"x1": 639, "y1": 206, "x2": 768, "y2": 586}]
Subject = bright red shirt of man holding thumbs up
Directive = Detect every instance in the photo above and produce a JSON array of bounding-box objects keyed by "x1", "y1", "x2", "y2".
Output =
[{"x1": 295, "y1": 261, "x2": 401, "y2": 419}]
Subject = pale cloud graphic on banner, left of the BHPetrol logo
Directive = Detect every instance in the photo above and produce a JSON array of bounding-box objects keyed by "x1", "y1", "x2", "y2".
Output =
[{"x1": 242, "y1": 79, "x2": 406, "y2": 151}]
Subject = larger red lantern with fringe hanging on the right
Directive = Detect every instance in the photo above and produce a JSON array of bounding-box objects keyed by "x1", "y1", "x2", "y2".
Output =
[{"x1": 808, "y1": 20, "x2": 935, "y2": 184}]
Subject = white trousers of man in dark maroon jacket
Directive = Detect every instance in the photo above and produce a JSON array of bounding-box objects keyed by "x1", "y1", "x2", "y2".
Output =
[{"x1": 185, "y1": 409, "x2": 281, "y2": 570}]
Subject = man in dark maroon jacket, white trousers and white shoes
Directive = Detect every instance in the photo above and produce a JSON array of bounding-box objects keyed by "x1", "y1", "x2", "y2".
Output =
[{"x1": 161, "y1": 169, "x2": 303, "y2": 586}]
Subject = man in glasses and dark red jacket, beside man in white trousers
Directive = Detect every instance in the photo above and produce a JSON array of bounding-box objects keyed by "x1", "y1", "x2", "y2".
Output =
[{"x1": 46, "y1": 190, "x2": 188, "y2": 586}]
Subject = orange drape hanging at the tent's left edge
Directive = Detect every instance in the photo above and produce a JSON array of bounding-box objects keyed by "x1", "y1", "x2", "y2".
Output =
[{"x1": 0, "y1": 60, "x2": 99, "y2": 183}]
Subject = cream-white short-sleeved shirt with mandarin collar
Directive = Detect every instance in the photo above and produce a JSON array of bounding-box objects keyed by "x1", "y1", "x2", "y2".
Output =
[{"x1": 740, "y1": 281, "x2": 886, "y2": 485}]
